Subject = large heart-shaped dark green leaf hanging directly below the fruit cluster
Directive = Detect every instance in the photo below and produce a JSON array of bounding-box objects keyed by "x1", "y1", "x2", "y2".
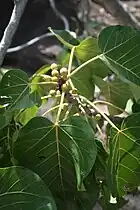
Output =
[{"x1": 14, "y1": 116, "x2": 97, "y2": 192}]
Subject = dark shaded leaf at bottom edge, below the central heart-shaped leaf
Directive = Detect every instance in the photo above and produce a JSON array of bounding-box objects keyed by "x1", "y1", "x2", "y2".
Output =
[{"x1": 55, "y1": 170, "x2": 99, "y2": 210}]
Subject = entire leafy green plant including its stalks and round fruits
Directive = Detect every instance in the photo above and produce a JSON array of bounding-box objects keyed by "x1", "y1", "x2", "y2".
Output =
[{"x1": 0, "y1": 26, "x2": 140, "y2": 210}]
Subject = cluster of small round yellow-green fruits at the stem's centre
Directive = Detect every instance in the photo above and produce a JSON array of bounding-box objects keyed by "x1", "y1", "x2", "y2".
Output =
[{"x1": 46, "y1": 63, "x2": 77, "y2": 97}]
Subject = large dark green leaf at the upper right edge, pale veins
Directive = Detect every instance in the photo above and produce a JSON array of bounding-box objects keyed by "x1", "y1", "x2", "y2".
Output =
[{"x1": 98, "y1": 26, "x2": 140, "y2": 85}]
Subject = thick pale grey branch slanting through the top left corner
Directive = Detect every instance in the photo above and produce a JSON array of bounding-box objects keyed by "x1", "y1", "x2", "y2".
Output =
[{"x1": 0, "y1": 0, "x2": 28, "y2": 66}]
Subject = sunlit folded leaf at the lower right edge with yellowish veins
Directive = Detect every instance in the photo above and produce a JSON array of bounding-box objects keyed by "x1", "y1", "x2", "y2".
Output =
[{"x1": 107, "y1": 113, "x2": 140, "y2": 196}]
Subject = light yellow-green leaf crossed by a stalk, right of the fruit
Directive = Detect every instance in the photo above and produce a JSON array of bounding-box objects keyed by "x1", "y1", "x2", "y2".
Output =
[{"x1": 71, "y1": 37, "x2": 109, "y2": 99}]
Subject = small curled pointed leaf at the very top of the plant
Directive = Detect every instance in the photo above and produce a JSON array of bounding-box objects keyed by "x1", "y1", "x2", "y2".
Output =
[{"x1": 49, "y1": 27, "x2": 79, "y2": 49}]
